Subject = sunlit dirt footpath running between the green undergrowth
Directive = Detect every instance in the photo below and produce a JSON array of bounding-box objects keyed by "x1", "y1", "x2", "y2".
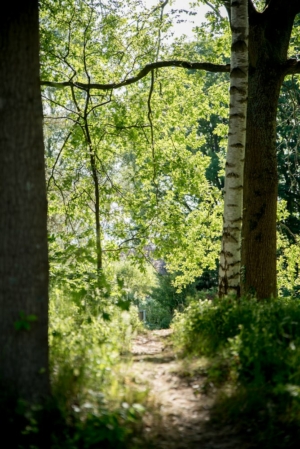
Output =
[{"x1": 127, "y1": 329, "x2": 253, "y2": 449}]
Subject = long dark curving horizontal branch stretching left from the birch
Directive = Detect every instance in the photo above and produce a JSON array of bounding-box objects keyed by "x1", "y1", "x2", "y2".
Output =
[{"x1": 41, "y1": 59, "x2": 230, "y2": 91}]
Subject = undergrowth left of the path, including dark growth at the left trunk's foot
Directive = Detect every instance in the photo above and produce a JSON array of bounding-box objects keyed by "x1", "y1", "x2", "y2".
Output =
[{"x1": 0, "y1": 290, "x2": 148, "y2": 449}]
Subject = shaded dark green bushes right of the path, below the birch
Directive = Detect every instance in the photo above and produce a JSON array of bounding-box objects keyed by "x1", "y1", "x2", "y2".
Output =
[{"x1": 173, "y1": 298, "x2": 300, "y2": 447}]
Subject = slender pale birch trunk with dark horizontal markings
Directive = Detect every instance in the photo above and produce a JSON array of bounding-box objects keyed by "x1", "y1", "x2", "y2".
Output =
[{"x1": 219, "y1": 0, "x2": 249, "y2": 296}]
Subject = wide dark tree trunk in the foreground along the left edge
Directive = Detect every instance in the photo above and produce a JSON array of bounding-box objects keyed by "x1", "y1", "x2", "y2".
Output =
[{"x1": 0, "y1": 0, "x2": 49, "y2": 402}]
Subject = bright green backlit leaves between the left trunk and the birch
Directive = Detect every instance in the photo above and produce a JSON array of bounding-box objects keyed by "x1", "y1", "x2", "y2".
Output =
[{"x1": 41, "y1": 0, "x2": 229, "y2": 286}]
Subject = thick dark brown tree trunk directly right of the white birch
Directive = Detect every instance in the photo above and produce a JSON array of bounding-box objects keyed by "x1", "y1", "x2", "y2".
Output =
[{"x1": 242, "y1": 0, "x2": 300, "y2": 299}]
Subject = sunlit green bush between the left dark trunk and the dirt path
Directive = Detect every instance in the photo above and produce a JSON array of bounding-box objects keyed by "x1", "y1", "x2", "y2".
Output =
[{"x1": 50, "y1": 292, "x2": 146, "y2": 449}]
